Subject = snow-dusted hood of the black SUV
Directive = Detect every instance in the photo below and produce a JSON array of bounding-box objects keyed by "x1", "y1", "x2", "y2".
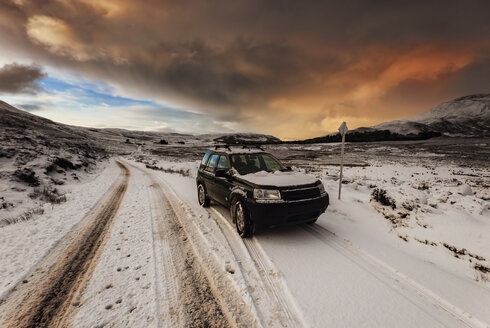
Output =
[{"x1": 236, "y1": 171, "x2": 318, "y2": 187}]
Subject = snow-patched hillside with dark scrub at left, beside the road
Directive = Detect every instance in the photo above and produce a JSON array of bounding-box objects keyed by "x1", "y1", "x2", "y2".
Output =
[{"x1": 0, "y1": 101, "x2": 107, "y2": 226}]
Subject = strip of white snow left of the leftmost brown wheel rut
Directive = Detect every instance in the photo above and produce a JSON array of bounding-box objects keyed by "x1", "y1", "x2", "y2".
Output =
[{"x1": 0, "y1": 161, "x2": 120, "y2": 299}]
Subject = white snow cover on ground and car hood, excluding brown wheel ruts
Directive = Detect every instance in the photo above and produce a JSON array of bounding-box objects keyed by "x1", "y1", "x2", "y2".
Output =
[{"x1": 0, "y1": 146, "x2": 490, "y2": 327}]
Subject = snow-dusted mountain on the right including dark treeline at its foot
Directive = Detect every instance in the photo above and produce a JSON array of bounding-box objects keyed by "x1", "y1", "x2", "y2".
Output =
[{"x1": 300, "y1": 94, "x2": 490, "y2": 143}]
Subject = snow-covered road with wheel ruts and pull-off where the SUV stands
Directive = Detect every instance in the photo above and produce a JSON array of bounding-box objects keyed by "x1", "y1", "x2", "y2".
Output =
[{"x1": 0, "y1": 159, "x2": 490, "y2": 327}]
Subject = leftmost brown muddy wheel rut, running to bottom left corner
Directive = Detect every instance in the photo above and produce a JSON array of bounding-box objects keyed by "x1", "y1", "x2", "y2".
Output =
[{"x1": 0, "y1": 161, "x2": 130, "y2": 328}]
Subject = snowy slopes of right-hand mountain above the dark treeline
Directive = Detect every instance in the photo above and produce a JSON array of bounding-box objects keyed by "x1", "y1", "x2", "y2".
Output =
[{"x1": 373, "y1": 94, "x2": 490, "y2": 137}]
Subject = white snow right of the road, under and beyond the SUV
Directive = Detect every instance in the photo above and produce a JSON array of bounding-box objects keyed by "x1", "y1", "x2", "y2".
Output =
[{"x1": 137, "y1": 152, "x2": 490, "y2": 327}]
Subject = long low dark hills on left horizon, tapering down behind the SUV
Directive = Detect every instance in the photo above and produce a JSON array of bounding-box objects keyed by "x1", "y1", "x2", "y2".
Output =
[{"x1": 0, "y1": 100, "x2": 281, "y2": 150}]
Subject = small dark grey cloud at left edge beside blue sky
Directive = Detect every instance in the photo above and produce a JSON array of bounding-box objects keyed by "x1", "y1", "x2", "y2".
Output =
[{"x1": 0, "y1": 63, "x2": 46, "y2": 93}]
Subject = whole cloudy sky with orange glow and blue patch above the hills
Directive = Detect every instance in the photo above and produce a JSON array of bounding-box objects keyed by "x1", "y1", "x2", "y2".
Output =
[{"x1": 0, "y1": 0, "x2": 490, "y2": 139}]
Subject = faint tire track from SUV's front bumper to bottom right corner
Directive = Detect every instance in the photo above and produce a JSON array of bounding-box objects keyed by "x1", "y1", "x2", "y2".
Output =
[{"x1": 302, "y1": 224, "x2": 490, "y2": 328}]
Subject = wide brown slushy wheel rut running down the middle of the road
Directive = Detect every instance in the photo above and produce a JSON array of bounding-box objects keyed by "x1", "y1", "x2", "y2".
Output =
[{"x1": 130, "y1": 164, "x2": 232, "y2": 327}]
